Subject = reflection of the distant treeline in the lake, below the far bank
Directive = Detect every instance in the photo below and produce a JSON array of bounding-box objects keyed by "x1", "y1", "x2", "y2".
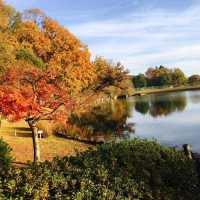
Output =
[{"x1": 135, "y1": 94, "x2": 187, "y2": 117}]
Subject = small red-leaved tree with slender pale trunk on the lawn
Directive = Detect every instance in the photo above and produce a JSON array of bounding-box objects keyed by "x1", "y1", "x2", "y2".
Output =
[{"x1": 0, "y1": 64, "x2": 73, "y2": 162}]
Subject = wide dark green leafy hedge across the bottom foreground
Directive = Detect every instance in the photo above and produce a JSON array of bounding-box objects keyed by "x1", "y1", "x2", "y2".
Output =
[{"x1": 0, "y1": 139, "x2": 200, "y2": 200}]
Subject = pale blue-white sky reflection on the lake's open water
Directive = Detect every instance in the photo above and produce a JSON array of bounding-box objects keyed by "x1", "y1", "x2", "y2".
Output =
[{"x1": 128, "y1": 91, "x2": 200, "y2": 152}]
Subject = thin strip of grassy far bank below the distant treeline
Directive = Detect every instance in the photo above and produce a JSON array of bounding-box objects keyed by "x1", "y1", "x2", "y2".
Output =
[{"x1": 130, "y1": 85, "x2": 200, "y2": 96}]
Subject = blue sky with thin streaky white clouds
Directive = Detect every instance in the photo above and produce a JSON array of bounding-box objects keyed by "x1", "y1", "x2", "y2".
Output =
[{"x1": 6, "y1": 0, "x2": 200, "y2": 75}]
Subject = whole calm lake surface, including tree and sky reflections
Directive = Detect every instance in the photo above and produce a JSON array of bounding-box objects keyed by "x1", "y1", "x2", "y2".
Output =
[{"x1": 62, "y1": 91, "x2": 200, "y2": 152}]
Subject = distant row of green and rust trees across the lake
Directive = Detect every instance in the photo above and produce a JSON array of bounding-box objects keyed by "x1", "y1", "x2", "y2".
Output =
[{"x1": 133, "y1": 66, "x2": 200, "y2": 88}]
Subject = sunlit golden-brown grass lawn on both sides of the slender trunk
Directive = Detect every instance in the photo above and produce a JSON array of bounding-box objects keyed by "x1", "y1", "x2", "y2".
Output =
[{"x1": 0, "y1": 120, "x2": 90, "y2": 163}]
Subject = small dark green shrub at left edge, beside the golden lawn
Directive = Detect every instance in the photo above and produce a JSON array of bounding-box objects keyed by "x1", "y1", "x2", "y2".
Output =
[{"x1": 0, "y1": 138, "x2": 13, "y2": 174}]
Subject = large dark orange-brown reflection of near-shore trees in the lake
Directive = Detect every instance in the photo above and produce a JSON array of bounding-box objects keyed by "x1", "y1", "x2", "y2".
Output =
[{"x1": 61, "y1": 101, "x2": 134, "y2": 142}]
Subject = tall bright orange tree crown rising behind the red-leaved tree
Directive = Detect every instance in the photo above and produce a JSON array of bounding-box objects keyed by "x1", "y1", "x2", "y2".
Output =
[{"x1": 43, "y1": 18, "x2": 96, "y2": 93}]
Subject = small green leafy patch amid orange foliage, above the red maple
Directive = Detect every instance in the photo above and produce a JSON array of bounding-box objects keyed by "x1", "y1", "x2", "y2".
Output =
[{"x1": 16, "y1": 49, "x2": 46, "y2": 69}]
